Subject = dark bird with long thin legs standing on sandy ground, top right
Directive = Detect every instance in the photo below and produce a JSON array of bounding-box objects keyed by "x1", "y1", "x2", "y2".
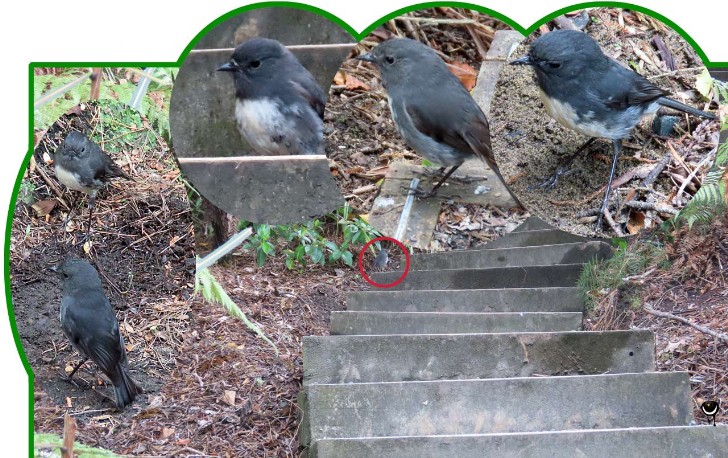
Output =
[{"x1": 511, "y1": 30, "x2": 715, "y2": 229}]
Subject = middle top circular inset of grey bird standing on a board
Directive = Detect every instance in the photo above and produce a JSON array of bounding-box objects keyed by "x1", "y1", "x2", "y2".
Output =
[{"x1": 325, "y1": 8, "x2": 525, "y2": 250}]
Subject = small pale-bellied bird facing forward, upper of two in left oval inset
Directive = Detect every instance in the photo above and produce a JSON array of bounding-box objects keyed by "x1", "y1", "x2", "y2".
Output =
[{"x1": 53, "y1": 131, "x2": 133, "y2": 235}]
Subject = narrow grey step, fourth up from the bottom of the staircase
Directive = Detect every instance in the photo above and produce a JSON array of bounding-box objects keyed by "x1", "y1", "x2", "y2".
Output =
[{"x1": 330, "y1": 312, "x2": 582, "y2": 335}]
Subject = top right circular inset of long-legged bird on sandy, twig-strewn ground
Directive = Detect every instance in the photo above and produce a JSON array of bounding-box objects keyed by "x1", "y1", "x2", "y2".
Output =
[{"x1": 491, "y1": 8, "x2": 719, "y2": 237}]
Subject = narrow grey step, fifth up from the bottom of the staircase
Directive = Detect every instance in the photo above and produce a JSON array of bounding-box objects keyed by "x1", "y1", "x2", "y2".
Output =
[{"x1": 346, "y1": 287, "x2": 584, "y2": 313}]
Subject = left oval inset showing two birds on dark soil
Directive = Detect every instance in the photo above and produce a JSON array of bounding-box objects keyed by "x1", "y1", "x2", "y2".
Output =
[{"x1": 9, "y1": 100, "x2": 195, "y2": 432}]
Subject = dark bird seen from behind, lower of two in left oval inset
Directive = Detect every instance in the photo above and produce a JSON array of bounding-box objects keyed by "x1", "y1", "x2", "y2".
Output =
[{"x1": 51, "y1": 259, "x2": 142, "y2": 409}]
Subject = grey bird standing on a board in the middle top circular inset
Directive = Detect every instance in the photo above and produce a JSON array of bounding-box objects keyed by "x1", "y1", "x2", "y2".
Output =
[{"x1": 358, "y1": 38, "x2": 523, "y2": 207}]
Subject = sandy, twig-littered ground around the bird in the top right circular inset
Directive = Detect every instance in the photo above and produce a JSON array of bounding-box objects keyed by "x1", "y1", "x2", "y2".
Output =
[{"x1": 489, "y1": 8, "x2": 719, "y2": 237}]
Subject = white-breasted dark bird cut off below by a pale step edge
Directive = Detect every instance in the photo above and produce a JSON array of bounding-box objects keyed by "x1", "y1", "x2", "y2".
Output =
[{"x1": 218, "y1": 38, "x2": 326, "y2": 155}]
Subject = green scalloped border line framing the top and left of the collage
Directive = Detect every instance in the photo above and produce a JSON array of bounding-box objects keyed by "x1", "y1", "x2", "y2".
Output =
[{"x1": 4, "y1": 1, "x2": 728, "y2": 457}]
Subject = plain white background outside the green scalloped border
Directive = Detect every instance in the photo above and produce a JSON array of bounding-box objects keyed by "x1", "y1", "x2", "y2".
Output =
[{"x1": 0, "y1": 0, "x2": 728, "y2": 450}]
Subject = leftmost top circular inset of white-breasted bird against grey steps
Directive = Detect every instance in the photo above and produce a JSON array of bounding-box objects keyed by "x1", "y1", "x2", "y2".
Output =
[{"x1": 170, "y1": 7, "x2": 354, "y2": 224}]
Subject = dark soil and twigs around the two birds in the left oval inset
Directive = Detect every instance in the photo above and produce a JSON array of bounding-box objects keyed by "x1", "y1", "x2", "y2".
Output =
[{"x1": 10, "y1": 102, "x2": 194, "y2": 453}]
